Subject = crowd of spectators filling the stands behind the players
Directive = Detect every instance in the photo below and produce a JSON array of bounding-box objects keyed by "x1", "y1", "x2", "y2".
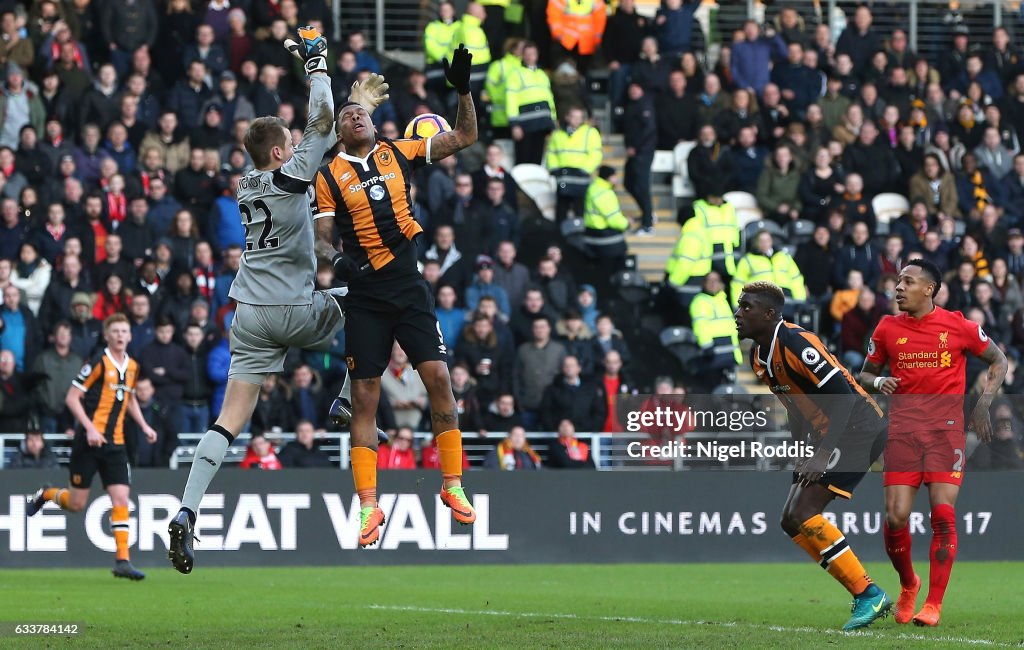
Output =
[{"x1": 0, "y1": 0, "x2": 1024, "y2": 469}]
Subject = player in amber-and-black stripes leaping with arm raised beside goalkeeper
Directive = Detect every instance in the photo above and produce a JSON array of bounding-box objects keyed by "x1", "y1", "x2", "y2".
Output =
[{"x1": 313, "y1": 45, "x2": 476, "y2": 547}]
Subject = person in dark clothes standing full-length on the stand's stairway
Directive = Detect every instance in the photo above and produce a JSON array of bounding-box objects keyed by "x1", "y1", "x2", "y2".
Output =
[{"x1": 622, "y1": 82, "x2": 655, "y2": 235}]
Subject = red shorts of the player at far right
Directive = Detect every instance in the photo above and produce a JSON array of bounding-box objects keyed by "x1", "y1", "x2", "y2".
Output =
[{"x1": 882, "y1": 429, "x2": 967, "y2": 487}]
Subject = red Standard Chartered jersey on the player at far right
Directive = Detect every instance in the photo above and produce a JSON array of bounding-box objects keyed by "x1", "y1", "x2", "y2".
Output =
[{"x1": 867, "y1": 307, "x2": 988, "y2": 433}]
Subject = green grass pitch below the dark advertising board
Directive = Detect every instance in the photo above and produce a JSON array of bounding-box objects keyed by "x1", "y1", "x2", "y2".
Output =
[{"x1": 0, "y1": 556, "x2": 1024, "y2": 649}]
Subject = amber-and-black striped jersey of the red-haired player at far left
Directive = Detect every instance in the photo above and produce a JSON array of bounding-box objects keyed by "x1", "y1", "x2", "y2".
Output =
[{"x1": 72, "y1": 348, "x2": 138, "y2": 444}]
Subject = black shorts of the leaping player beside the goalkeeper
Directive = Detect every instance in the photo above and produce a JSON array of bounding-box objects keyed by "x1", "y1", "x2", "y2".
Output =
[{"x1": 345, "y1": 275, "x2": 447, "y2": 379}]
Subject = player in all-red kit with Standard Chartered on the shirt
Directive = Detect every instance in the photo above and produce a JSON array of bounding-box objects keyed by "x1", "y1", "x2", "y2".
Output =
[{"x1": 860, "y1": 260, "x2": 1007, "y2": 625}]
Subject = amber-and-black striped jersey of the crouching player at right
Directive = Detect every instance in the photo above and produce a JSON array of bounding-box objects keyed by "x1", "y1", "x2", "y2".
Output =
[{"x1": 751, "y1": 320, "x2": 885, "y2": 436}]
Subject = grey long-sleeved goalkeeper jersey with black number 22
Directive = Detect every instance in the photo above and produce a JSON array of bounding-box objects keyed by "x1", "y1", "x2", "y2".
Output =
[{"x1": 228, "y1": 74, "x2": 335, "y2": 305}]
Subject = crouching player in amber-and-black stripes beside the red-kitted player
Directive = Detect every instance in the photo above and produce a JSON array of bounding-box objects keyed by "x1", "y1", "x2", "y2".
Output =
[{"x1": 734, "y1": 281, "x2": 892, "y2": 630}]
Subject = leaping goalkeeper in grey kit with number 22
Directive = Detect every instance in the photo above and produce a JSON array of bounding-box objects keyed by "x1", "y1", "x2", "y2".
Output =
[{"x1": 168, "y1": 27, "x2": 387, "y2": 573}]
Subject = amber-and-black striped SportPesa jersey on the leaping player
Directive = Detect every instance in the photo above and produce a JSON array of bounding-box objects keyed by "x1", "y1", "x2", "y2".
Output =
[{"x1": 312, "y1": 138, "x2": 430, "y2": 284}]
